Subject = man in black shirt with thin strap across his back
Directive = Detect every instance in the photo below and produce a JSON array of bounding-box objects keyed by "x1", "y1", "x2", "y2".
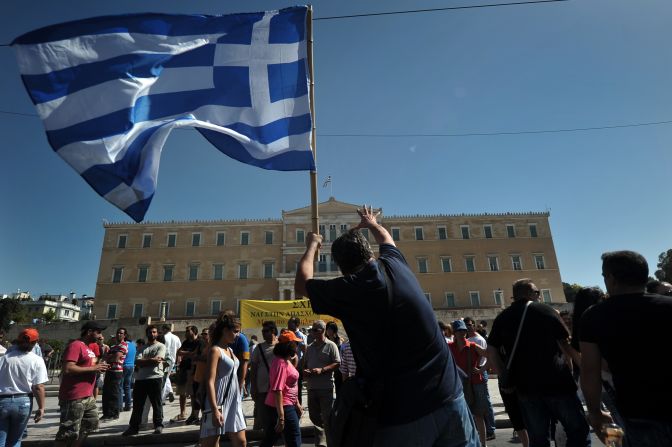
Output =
[{"x1": 488, "y1": 278, "x2": 590, "y2": 447}]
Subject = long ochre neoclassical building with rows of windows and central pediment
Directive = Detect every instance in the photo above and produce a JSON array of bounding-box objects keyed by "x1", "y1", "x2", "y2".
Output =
[{"x1": 94, "y1": 197, "x2": 565, "y2": 319}]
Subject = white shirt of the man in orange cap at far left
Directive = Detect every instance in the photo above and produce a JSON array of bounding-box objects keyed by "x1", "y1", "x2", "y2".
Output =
[{"x1": 0, "y1": 349, "x2": 49, "y2": 395}]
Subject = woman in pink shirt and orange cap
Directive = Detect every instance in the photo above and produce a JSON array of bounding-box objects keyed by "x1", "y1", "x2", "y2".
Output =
[{"x1": 260, "y1": 330, "x2": 303, "y2": 447}]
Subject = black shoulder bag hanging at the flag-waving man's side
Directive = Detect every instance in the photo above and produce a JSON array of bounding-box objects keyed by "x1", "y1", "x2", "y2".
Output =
[{"x1": 327, "y1": 259, "x2": 392, "y2": 447}]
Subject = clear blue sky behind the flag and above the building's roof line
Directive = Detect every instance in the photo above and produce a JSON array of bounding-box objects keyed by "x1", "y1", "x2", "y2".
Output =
[{"x1": 0, "y1": 0, "x2": 672, "y2": 295}]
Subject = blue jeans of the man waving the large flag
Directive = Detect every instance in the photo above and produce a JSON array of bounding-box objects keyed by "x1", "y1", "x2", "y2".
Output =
[{"x1": 374, "y1": 395, "x2": 481, "y2": 447}]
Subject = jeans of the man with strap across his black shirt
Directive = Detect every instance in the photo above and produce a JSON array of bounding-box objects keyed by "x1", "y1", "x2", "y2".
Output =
[{"x1": 518, "y1": 393, "x2": 590, "y2": 447}]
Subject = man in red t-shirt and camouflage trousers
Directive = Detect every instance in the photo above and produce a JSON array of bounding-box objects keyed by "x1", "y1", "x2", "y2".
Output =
[{"x1": 56, "y1": 321, "x2": 108, "y2": 447}]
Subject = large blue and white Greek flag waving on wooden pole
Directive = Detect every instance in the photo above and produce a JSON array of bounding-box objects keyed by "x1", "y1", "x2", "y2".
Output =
[{"x1": 12, "y1": 7, "x2": 315, "y2": 222}]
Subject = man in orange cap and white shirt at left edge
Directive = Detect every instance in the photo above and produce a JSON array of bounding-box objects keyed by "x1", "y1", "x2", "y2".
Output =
[{"x1": 0, "y1": 328, "x2": 49, "y2": 446}]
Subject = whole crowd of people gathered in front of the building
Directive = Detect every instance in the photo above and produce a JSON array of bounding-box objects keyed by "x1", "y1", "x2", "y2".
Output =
[{"x1": 0, "y1": 206, "x2": 672, "y2": 447}]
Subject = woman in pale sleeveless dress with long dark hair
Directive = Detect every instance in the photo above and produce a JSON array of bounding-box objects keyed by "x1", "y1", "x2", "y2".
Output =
[{"x1": 201, "y1": 315, "x2": 247, "y2": 447}]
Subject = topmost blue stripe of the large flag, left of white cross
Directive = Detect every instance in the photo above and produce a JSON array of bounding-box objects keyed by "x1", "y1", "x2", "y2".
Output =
[{"x1": 12, "y1": 12, "x2": 264, "y2": 45}]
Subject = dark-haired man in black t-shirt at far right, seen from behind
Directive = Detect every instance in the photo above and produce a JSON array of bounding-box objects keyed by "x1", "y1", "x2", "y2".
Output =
[{"x1": 579, "y1": 251, "x2": 672, "y2": 447}]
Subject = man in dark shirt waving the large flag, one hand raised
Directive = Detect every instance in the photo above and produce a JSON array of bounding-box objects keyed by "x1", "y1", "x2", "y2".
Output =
[{"x1": 294, "y1": 206, "x2": 479, "y2": 447}]
